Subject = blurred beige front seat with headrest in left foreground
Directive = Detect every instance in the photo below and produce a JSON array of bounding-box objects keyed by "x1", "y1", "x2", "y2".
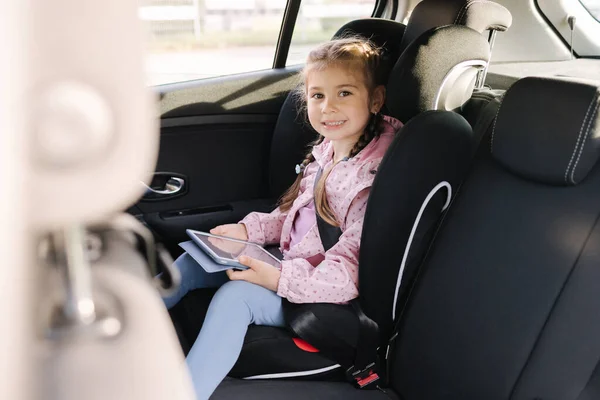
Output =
[{"x1": 0, "y1": 0, "x2": 193, "y2": 400}]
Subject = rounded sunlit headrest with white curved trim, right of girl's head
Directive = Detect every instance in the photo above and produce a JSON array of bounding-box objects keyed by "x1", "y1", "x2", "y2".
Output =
[{"x1": 386, "y1": 25, "x2": 490, "y2": 123}]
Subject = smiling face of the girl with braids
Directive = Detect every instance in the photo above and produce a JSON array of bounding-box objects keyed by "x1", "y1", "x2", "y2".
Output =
[{"x1": 306, "y1": 65, "x2": 384, "y2": 145}]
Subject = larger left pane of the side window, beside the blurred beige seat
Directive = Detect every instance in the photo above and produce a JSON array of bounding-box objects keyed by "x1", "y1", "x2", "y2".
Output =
[{"x1": 139, "y1": 0, "x2": 287, "y2": 85}]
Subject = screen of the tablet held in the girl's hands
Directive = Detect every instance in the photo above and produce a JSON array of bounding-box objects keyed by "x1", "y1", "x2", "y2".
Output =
[{"x1": 192, "y1": 232, "x2": 281, "y2": 267}]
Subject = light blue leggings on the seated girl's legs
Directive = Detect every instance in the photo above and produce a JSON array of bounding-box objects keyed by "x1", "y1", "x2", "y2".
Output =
[{"x1": 164, "y1": 253, "x2": 285, "y2": 400}]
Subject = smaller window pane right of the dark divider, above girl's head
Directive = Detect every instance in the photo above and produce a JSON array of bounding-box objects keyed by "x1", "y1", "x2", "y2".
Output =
[{"x1": 286, "y1": 0, "x2": 375, "y2": 65}]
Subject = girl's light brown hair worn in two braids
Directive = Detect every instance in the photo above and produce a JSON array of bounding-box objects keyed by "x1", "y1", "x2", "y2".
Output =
[{"x1": 279, "y1": 37, "x2": 383, "y2": 226}]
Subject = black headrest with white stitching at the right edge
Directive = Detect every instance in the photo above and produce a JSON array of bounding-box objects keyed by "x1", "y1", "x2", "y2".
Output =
[{"x1": 490, "y1": 77, "x2": 600, "y2": 186}]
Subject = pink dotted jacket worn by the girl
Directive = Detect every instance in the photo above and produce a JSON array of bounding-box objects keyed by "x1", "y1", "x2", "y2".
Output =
[{"x1": 240, "y1": 116, "x2": 402, "y2": 303}]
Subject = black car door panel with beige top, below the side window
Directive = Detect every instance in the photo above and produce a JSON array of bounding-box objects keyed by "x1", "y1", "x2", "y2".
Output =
[{"x1": 137, "y1": 68, "x2": 298, "y2": 254}]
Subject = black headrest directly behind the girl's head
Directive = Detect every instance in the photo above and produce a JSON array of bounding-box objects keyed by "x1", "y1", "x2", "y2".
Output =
[{"x1": 333, "y1": 18, "x2": 406, "y2": 85}]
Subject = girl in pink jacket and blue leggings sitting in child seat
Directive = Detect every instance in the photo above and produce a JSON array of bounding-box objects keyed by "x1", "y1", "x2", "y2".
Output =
[{"x1": 165, "y1": 38, "x2": 402, "y2": 399}]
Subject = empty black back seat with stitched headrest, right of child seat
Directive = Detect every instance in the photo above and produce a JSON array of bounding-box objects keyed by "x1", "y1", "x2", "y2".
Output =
[{"x1": 212, "y1": 78, "x2": 600, "y2": 400}]
